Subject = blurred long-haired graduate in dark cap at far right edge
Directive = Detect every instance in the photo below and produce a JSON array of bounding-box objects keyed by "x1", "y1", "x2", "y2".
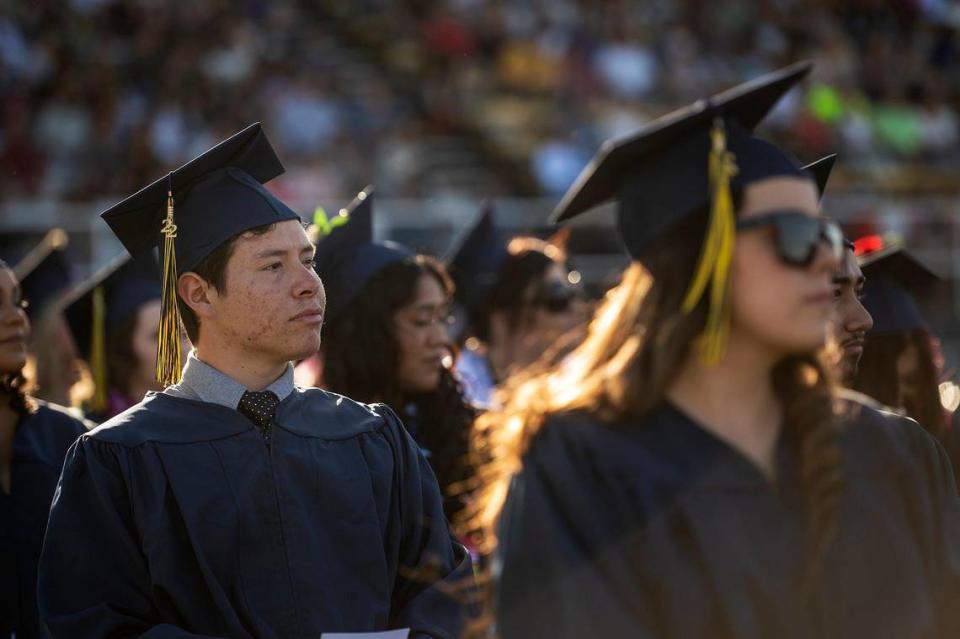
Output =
[{"x1": 854, "y1": 248, "x2": 960, "y2": 484}]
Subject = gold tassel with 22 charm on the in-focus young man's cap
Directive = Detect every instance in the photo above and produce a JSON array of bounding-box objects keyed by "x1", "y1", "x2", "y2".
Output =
[{"x1": 157, "y1": 185, "x2": 181, "y2": 386}]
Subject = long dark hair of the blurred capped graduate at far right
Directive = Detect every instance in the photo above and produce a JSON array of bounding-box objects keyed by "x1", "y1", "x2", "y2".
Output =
[{"x1": 854, "y1": 328, "x2": 950, "y2": 445}]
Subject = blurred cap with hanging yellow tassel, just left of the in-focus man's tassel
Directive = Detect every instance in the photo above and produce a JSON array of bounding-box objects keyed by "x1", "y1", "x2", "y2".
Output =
[{"x1": 64, "y1": 252, "x2": 161, "y2": 411}]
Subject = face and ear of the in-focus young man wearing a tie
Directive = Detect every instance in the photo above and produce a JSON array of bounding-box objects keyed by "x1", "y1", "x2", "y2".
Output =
[{"x1": 203, "y1": 220, "x2": 326, "y2": 363}]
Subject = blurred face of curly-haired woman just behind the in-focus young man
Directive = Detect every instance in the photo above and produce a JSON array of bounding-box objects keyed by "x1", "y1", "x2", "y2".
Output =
[{"x1": 393, "y1": 273, "x2": 450, "y2": 394}]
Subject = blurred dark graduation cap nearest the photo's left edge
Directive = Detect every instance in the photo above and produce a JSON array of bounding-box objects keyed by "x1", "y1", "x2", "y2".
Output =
[{"x1": 0, "y1": 228, "x2": 73, "y2": 320}]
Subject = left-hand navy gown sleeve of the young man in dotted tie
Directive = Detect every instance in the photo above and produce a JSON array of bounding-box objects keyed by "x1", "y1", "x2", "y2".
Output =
[{"x1": 38, "y1": 436, "x2": 226, "y2": 639}]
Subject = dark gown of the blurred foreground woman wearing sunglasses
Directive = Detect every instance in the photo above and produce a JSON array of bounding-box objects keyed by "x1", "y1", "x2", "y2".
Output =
[{"x1": 495, "y1": 403, "x2": 960, "y2": 639}]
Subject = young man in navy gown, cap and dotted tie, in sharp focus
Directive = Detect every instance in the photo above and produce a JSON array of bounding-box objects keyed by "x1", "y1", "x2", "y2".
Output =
[{"x1": 39, "y1": 124, "x2": 470, "y2": 639}]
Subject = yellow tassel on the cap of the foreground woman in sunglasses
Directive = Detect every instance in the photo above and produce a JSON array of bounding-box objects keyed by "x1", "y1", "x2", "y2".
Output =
[{"x1": 683, "y1": 118, "x2": 737, "y2": 365}]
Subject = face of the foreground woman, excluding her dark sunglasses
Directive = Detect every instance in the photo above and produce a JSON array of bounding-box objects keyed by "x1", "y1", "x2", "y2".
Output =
[{"x1": 730, "y1": 177, "x2": 838, "y2": 359}]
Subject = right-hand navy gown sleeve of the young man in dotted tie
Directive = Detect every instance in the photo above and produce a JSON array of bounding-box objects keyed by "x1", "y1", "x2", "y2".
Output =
[{"x1": 378, "y1": 407, "x2": 474, "y2": 639}]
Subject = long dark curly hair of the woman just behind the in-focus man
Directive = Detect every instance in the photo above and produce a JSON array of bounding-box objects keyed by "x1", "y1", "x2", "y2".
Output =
[{"x1": 321, "y1": 255, "x2": 476, "y2": 516}]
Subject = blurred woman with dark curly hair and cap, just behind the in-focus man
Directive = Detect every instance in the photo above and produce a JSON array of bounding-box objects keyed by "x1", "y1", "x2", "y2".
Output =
[{"x1": 315, "y1": 191, "x2": 476, "y2": 519}]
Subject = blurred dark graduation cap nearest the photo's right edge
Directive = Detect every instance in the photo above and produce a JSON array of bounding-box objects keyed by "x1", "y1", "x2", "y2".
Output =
[{"x1": 860, "y1": 247, "x2": 940, "y2": 335}]
